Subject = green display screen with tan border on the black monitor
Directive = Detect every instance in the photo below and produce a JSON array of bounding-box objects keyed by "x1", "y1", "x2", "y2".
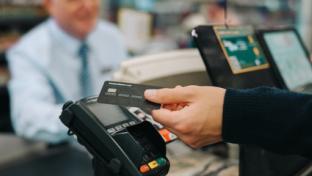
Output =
[{"x1": 214, "y1": 26, "x2": 269, "y2": 74}]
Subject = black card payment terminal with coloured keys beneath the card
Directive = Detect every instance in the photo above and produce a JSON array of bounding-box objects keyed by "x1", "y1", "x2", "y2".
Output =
[{"x1": 60, "y1": 97, "x2": 170, "y2": 176}]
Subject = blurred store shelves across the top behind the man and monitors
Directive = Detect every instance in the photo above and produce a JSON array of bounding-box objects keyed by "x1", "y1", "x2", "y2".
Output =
[{"x1": 0, "y1": 0, "x2": 312, "y2": 55}]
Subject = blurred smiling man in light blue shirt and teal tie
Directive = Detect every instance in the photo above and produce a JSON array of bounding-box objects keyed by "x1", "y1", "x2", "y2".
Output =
[{"x1": 7, "y1": 0, "x2": 126, "y2": 143}]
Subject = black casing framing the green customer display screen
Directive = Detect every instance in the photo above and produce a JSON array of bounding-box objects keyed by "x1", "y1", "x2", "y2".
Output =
[{"x1": 192, "y1": 25, "x2": 279, "y2": 88}]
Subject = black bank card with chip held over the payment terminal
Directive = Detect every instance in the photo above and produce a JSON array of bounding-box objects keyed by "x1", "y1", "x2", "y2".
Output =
[{"x1": 98, "y1": 81, "x2": 161, "y2": 112}]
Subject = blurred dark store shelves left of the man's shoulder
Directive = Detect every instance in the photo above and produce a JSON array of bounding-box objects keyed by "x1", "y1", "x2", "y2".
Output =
[{"x1": 0, "y1": 3, "x2": 47, "y2": 86}]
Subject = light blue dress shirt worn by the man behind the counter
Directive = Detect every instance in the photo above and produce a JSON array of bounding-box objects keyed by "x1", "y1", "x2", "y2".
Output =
[{"x1": 7, "y1": 19, "x2": 127, "y2": 143}]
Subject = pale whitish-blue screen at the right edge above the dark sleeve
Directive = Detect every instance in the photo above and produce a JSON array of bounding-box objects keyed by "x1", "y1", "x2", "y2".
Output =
[{"x1": 264, "y1": 30, "x2": 312, "y2": 90}]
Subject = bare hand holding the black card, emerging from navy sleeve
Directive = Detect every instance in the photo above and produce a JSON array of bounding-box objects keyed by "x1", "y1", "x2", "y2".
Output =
[{"x1": 144, "y1": 86, "x2": 226, "y2": 148}]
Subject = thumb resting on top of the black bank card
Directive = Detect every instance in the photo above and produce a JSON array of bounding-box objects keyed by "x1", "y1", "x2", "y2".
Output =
[{"x1": 144, "y1": 87, "x2": 190, "y2": 104}]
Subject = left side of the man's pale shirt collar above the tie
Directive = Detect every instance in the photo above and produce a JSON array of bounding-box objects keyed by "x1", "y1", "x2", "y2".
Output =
[{"x1": 48, "y1": 18, "x2": 88, "y2": 53}]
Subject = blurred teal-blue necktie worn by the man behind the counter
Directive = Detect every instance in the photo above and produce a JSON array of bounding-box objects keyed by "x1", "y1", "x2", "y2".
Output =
[{"x1": 78, "y1": 43, "x2": 92, "y2": 97}]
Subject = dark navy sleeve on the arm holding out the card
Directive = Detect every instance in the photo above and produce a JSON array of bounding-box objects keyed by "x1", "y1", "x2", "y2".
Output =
[{"x1": 222, "y1": 87, "x2": 312, "y2": 158}]
